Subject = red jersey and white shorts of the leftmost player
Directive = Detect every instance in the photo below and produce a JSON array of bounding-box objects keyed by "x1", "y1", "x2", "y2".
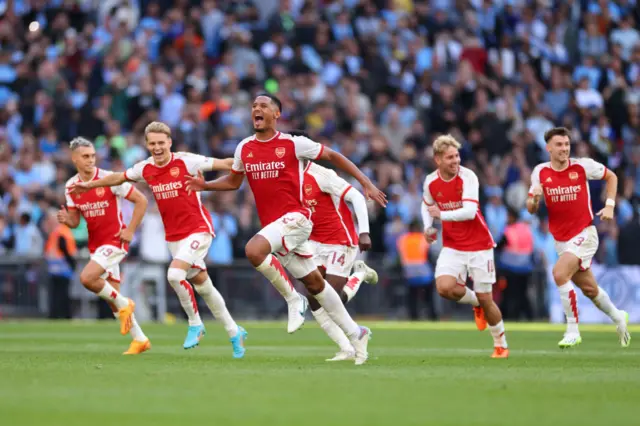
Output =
[{"x1": 65, "y1": 168, "x2": 133, "y2": 282}]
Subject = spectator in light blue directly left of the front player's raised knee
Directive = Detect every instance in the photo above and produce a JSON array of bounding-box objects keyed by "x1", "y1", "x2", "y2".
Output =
[{"x1": 208, "y1": 197, "x2": 238, "y2": 265}]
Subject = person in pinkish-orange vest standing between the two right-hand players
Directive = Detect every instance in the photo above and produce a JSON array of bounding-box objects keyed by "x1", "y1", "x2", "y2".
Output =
[{"x1": 497, "y1": 209, "x2": 534, "y2": 321}]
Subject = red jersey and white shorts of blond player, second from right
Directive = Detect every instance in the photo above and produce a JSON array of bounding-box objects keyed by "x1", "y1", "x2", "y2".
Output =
[{"x1": 423, "y1": 166, "x2": 496, "y2": 293}]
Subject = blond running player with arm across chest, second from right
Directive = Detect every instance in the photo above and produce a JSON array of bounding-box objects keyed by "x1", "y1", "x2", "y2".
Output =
[{"x1": 422, "y1": 135, "x2": 509, "y2": 358}]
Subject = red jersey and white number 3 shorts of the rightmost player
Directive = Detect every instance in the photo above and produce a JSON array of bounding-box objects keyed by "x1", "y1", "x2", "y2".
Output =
[{"x1": 529, "y1": 158, "x2": 607, "y2": 270}]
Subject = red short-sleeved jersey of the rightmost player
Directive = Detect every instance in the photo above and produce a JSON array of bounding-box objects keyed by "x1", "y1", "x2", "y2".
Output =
[{"x1": 529, "y1": 158, "x2": 607, "y2": 241}]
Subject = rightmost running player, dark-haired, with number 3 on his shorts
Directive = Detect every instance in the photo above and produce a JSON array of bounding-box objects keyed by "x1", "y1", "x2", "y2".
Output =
[{"x1": 527, "y1": 127, "x2": 631, "y2": 348}]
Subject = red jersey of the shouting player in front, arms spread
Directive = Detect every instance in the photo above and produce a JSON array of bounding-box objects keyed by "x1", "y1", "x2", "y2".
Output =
[{"x1": 231, "y1": 132, "x2": 324, "y2": 226}]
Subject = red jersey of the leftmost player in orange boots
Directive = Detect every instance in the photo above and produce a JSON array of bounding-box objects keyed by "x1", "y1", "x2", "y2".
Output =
[{"x1": 65, "y1": 168, "x2": 133, "y2": 254}]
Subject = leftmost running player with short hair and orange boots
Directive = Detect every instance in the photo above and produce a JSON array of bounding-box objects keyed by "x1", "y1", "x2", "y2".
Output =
[{"x1": 58, "y1": 137, "x2": 151, "y2": 355}]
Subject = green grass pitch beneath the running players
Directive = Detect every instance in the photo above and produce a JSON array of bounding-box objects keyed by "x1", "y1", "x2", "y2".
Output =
[{"x1": 0, "y1": 321, "x2": 640, "y2": 426}]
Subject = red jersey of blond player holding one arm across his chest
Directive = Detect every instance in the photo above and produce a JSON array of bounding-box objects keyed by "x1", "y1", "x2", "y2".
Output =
[{"x1": 423, "y1": 167, "x2": 495, "y2": 251}]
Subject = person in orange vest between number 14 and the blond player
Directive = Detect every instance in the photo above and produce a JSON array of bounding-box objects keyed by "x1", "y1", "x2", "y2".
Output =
[{"x1": 396, "y1": 221, "x2": 438, "y2": 321}]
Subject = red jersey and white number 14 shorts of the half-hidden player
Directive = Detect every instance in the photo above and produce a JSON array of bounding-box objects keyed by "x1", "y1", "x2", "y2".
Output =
[{"x1": 303, "y1": 162, "x2": 369, "y2": 277}]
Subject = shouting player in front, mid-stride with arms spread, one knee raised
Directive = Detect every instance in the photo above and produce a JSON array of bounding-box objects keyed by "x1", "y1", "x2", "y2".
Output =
[{"x1": 187, "y1": 94, "x2": 387, "y2": 365}]
